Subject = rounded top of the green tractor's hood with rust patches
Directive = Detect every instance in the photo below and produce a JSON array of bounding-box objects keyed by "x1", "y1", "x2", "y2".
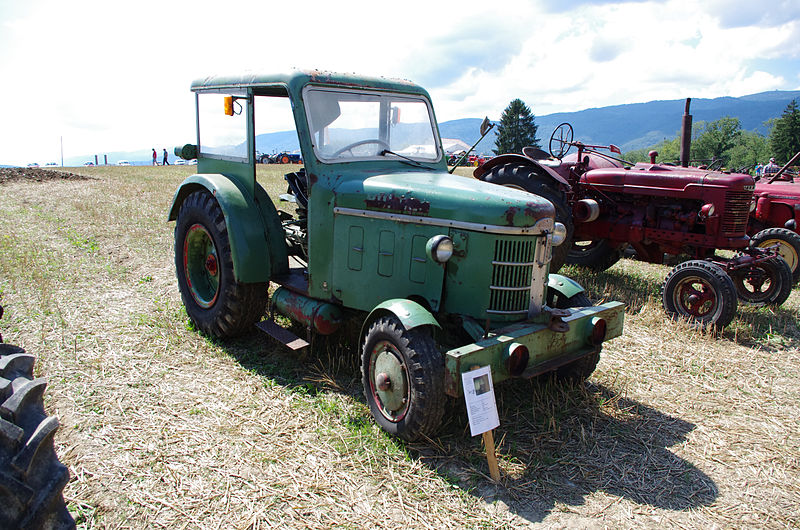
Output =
[{"x1": 334, "y1": 172, "x2": 555, "y2": 228}]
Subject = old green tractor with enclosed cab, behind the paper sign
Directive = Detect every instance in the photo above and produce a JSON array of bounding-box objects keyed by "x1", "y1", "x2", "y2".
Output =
[{"x1": 169, "y1": 71, "x2": 624, "y2": 440}]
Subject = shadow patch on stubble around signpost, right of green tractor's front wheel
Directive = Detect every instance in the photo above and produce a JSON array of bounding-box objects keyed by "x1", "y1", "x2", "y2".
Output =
[{"x1": 414, "y1": 381, "x2": 718, "y2": 522}]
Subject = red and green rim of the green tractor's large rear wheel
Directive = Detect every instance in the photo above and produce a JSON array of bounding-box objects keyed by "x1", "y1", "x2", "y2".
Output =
[{"x1": 183, "y1": 224, "x2": 220, "y2": 308}]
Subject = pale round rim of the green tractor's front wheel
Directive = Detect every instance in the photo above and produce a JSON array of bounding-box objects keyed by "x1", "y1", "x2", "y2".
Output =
[{"x1": 369, "y1": 341, "x2": 411, "y2": 423}]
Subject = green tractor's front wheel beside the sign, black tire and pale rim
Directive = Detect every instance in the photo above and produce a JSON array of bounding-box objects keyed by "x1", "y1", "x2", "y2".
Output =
[{"x1": 361, "y1": 316, "x2": 447, "y2": 441}]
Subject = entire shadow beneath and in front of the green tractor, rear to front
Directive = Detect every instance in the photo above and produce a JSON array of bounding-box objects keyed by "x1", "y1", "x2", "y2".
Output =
[{"x1": 209, "y1": 320, "x2": 718, "y2": 522}]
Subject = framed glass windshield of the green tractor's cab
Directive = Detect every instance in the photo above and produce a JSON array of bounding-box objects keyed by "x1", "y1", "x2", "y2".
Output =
[{"x1": 304, "y1": 87, "x2": 440, "y2": 162}]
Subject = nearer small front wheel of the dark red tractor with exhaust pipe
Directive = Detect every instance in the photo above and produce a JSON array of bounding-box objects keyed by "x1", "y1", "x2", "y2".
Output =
[{"x1": 661, "y1": 260, "x2": 738, "y2": 330}]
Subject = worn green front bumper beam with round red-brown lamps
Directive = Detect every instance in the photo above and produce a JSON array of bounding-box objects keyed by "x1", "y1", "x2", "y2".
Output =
[{"x1": 445, "y1": 302, "x2": 625, "y2": 397}]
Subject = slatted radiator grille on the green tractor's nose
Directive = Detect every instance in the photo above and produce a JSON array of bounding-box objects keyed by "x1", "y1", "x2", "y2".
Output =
[{"x1": 486, "y1": 237, "x2": 538, "y2": 315}]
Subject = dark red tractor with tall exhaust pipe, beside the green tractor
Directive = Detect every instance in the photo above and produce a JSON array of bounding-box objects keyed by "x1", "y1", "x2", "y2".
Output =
[{"x1": 474, "y1": 123, "x2": 792, "y2": 329}]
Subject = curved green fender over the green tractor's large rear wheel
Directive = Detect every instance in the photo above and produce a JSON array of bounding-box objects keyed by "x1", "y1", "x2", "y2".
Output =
[{"x1": 167, "y1": 173, "x2": 288, "y2": 283}]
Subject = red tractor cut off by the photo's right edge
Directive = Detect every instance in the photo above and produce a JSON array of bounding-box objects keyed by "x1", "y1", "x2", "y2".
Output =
[{"x1": 747, "y1": 152, "x2": 800, "y2": 283}]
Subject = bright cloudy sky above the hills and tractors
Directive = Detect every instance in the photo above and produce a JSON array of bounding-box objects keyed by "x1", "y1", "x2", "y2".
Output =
[{"x1": 0, "y1": 0, "x2": 800, "y2": 165}]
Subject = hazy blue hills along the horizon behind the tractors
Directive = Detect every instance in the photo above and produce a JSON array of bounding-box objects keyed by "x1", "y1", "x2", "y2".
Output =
[{"x1": 59, "y1": 90, "x2": 800, "y2": 165}]
